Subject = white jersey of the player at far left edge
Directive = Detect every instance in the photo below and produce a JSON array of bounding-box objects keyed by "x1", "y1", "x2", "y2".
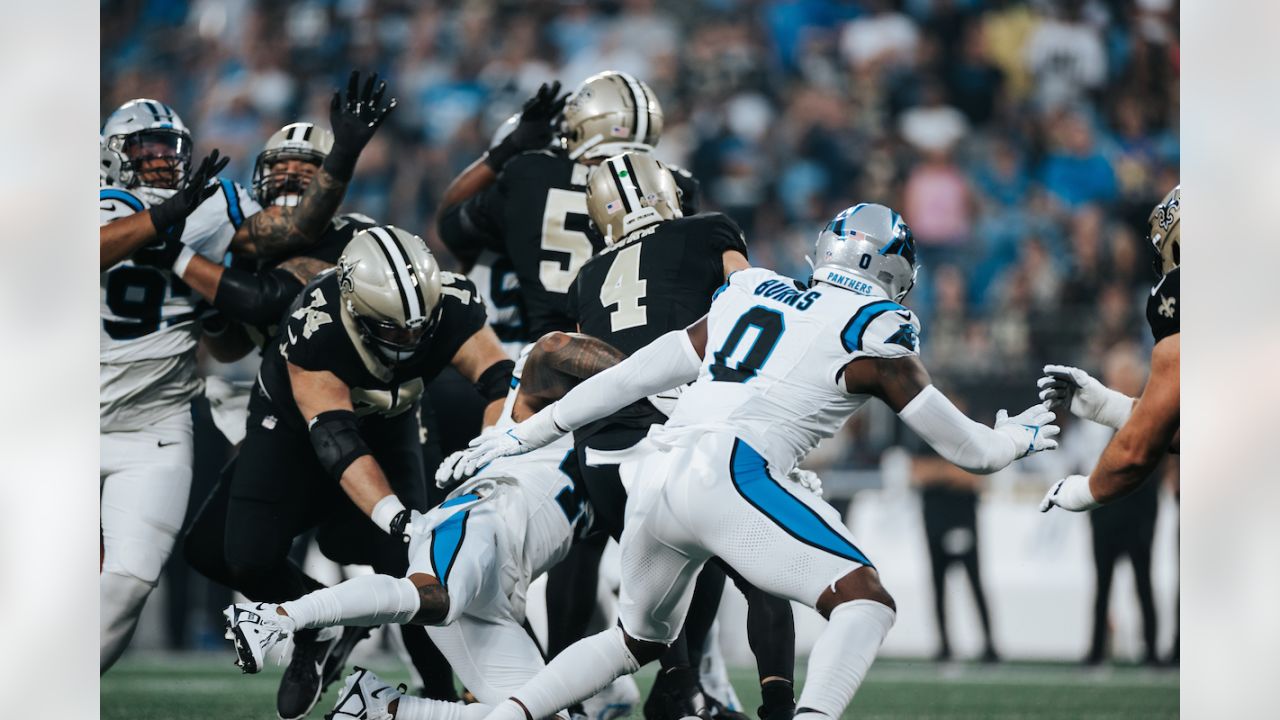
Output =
[{"x1": 99, "y1": 179, "x2": 261, "y2": 430}]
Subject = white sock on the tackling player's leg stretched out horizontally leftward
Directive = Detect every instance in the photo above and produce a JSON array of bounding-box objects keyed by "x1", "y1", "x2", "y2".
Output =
[{"x1": 280, "y1": 575, "x2": 420, "y2": 630}]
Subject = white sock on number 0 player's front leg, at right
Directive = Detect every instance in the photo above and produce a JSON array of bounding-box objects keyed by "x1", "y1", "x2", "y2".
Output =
[{"x1": 796, "y1": 600, "x2": 896, "y2": 720}]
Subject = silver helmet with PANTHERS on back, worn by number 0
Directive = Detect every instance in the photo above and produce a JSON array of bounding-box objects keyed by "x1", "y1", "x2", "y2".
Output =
[{"x1": 810, "y1": 202, "x2": 916, "y2": 302}]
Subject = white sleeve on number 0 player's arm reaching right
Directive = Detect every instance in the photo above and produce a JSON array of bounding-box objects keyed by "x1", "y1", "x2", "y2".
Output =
[{"x1": 897, "y1": 384, "x2": 1019, "y2": 474}]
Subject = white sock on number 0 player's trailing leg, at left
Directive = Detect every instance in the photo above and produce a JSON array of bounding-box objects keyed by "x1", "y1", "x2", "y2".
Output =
[{"x1": 489, "y1": 628, "x2": 640, "y2": 720}]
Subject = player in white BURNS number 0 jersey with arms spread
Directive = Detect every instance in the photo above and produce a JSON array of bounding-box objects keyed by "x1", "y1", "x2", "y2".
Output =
[{"x1": 442, "y1": 204, "x2": 1059, "y2": 720}]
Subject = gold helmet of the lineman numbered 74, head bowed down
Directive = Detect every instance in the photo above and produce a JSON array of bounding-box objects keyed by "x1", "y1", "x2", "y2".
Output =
[{"x1": 337, "y1": 225, "x2": 440, "y2": 364}]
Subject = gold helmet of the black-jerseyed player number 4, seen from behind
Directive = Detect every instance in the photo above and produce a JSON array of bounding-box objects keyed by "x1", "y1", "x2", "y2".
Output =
[{"x1": 586, "y1": 152, "x2": 684, "y2": 245}]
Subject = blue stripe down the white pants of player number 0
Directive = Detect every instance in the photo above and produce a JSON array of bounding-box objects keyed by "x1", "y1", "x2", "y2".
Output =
[{"x1": 730, "y1": 439, "x2": 874, "y2": 568}]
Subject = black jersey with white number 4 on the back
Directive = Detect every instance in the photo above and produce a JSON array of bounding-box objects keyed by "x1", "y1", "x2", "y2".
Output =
[{"x1": 568, "y1": 213, "x2": 746, "y2": 355}]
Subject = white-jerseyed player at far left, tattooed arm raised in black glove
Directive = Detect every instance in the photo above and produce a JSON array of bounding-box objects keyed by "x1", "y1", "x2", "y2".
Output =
[{"x1": 99, "y1": 73, "x2": 389, "y2": 673}]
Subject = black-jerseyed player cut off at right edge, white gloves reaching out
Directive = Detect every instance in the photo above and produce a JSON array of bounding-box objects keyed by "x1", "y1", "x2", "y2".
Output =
[{"x1": 1039, "y1": 186, "x2": 1183, "y2": 512}]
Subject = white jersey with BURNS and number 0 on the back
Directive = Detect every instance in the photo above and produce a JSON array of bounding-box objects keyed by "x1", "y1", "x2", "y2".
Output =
[{"x1": 667, "y1": 268, "x2": 920, "y2": 473}]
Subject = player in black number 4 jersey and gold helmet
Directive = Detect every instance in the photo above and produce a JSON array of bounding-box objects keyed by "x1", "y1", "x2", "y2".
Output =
[{"x1": 567, "y1": 152, "x2": 795, "y2": 719}]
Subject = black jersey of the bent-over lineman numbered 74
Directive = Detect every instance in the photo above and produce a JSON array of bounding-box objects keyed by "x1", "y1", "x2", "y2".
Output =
[{"x1": 259, "y1": 270, "x2": 485, "y2": 428}]
